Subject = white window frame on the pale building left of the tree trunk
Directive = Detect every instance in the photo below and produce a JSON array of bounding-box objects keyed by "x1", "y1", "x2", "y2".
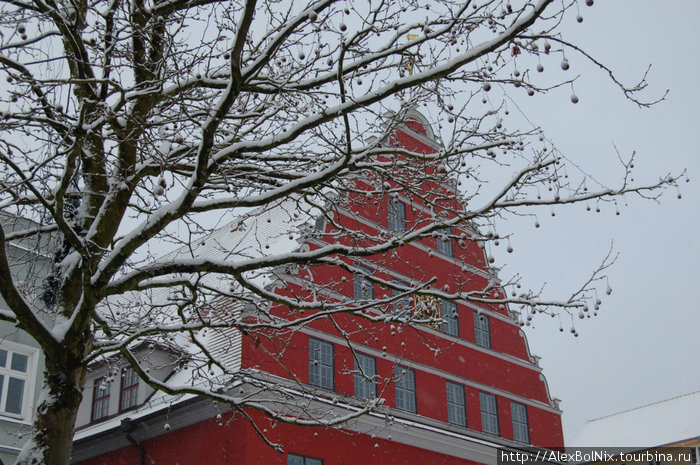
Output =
[{"x1": 0, "y1": 341, "x2": 39, "y2": 423}]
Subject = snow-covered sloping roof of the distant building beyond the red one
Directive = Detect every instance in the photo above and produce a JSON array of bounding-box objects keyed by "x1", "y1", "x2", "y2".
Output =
[{"x1": 568, "y1": 391, "x2": 700, "y2": 449}]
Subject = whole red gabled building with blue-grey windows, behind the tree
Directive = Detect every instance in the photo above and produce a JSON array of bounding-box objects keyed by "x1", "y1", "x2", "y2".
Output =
[{"x1": 74, "y1": 113, "x2": 563, "y2": 465}]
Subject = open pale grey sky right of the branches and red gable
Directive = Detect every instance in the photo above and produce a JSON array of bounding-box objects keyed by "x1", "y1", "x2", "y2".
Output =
[{"x1": 490, "y1": 0, "x2": 700, "y2": 442}]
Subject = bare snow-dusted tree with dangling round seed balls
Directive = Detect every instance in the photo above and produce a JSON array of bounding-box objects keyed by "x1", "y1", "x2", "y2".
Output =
[{"x1": 0, "y1": 0, "x2": 677, "y2": 464}]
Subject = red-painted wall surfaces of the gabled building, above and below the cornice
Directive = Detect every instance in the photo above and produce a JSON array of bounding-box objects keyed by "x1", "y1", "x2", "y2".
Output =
[{"x1": 72, "y1": 113, "x2": 563, "y2": 465}]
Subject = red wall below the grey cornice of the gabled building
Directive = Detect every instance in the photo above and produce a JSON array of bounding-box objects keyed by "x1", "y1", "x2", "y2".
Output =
[{"x1": 80, "y1": 414, "x2": 492, "y2": 465}]
